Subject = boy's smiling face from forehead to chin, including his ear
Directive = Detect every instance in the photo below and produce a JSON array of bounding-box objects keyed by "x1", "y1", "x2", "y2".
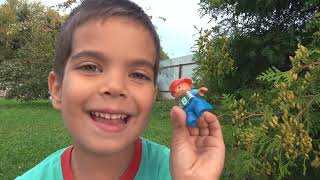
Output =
[{"x1": 49, "y1": 17, "x2": 156, "y2": 154}]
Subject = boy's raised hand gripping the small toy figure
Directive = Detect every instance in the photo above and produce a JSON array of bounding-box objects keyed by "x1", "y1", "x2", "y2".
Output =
[{"x1": 170, "y1": 106, "x2": 225, "y2": 180}]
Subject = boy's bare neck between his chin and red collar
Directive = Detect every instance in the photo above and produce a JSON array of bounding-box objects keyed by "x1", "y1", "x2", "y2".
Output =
[{"x1": 71, "y1": 144, "x2": 135, "y2": 180}]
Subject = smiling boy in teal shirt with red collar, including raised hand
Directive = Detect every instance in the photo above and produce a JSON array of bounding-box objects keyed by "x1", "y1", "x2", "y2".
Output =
[{"x1": 17, "y1": 0, "x2": 224, "y2": 180}]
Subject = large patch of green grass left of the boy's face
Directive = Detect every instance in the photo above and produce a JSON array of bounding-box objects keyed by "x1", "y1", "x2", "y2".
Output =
[{"x1": 0, "y1": 100, "x2": 70, "y2": 179}]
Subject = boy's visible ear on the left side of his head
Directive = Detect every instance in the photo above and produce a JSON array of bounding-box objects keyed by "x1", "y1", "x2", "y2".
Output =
[{"x1": 48, "y1": 71, "x2": 62, "y2": 110}]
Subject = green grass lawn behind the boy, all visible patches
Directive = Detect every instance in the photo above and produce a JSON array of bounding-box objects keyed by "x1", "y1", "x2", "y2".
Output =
[{"x1": 0, "y1": 99, "x2": 232, "y2": 179}]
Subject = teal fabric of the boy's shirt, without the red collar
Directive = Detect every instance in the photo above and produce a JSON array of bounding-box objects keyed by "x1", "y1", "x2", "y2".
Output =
[{"x1": 16, "y1": 138, "x2": 171, "y2": 180}]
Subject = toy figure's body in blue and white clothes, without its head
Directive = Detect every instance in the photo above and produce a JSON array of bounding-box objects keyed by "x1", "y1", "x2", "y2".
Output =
[{"x1": 179, "y1": 89, "x2": 213, "y2": 127}]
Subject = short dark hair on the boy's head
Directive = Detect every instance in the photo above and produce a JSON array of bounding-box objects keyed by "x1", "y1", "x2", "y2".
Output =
[{"x1": 54, "y1": 0, "x2": 160, "y2": 83}]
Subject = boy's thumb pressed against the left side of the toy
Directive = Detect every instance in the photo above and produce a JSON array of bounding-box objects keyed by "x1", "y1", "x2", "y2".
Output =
[{"x1": 170, "y1": 106, "x2": 190, "y2": 141}]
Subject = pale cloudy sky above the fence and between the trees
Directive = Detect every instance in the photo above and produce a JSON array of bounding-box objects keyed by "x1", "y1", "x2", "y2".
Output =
[{"x1": 0, "y1": 0, "x2": 213, "y2": 58}]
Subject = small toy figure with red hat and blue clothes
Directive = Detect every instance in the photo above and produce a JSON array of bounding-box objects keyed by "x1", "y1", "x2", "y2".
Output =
[{"x1": 169, "y1": 78, "x2": 213, "y2": 127}]
